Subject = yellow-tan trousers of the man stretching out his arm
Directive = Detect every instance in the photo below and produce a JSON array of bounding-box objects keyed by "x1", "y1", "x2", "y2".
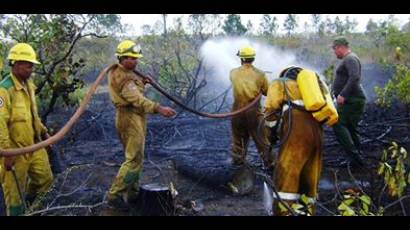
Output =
[{"x1": 108, "y1": 107, "x2": 146, "y2": 199}]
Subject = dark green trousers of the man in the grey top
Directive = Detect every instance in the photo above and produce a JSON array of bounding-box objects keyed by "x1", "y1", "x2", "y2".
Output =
[{"x1": 333, "y1": 98, "x2": 366, "y2": 154}]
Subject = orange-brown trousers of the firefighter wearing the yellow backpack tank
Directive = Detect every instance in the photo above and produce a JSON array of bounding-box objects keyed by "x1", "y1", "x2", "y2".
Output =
[{"x1": 273, "y1": 108, "x2": 323, "y2": 215}]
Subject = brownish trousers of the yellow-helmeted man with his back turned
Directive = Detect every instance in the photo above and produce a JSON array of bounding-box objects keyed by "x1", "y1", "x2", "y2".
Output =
[{"x1": 231, "y1": 107, "x2": 273, "y2": 167}]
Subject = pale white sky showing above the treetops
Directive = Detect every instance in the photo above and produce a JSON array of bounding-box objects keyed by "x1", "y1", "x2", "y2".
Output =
[{"x1": 120, "y1": 14, "x2": 410, "y2": 35}]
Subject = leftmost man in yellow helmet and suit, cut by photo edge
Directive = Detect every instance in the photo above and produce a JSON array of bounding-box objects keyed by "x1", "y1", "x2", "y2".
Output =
[{"x1": 0, "y1": 43, "x2": 53, "y2": 215}]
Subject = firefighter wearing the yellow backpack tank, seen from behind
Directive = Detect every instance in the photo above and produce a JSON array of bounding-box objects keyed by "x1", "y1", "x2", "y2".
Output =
[{"x1": 264, "y1": 67, "x2": 323, "y2": 215}]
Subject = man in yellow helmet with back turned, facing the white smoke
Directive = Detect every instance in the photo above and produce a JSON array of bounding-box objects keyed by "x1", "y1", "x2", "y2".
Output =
[{"x1": 230, "y1": 46, "x2": 273, "y2": 194}]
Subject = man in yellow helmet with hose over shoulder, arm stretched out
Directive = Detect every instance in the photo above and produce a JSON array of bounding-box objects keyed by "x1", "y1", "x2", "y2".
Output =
[{"x1": 107, "y1": 40, "x2": 175, "y2": 208}]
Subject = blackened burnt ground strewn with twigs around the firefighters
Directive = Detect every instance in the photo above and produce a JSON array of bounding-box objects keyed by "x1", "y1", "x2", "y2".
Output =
[{"x1": 0, "y1": 85, "x2": 410, "y2": 216}]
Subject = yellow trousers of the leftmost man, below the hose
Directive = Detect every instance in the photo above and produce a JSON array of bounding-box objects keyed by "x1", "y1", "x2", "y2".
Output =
[{"x1": 0, "y1": 149, "x2": 53, "y2": 216}]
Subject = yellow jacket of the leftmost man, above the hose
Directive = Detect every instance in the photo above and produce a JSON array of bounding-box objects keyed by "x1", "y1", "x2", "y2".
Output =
[{"x1": 0, "y1": 73, "x2": 47, "y2": 149}]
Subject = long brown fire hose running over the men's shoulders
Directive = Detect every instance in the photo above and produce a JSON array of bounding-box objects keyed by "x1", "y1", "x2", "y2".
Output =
[{"x1": 0, "y1": 64, "x2": 262, "y2": 157}]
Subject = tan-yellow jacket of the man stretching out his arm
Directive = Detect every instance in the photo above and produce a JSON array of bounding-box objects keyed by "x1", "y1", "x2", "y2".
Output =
[{"x1": 108, "y1": 64, "x2": 159, "y2": 115}]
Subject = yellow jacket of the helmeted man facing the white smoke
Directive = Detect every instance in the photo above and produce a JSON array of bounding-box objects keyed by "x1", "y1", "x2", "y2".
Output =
[{"x1": 229, "y1": 64, "x2": 269, "y2": 110}]
